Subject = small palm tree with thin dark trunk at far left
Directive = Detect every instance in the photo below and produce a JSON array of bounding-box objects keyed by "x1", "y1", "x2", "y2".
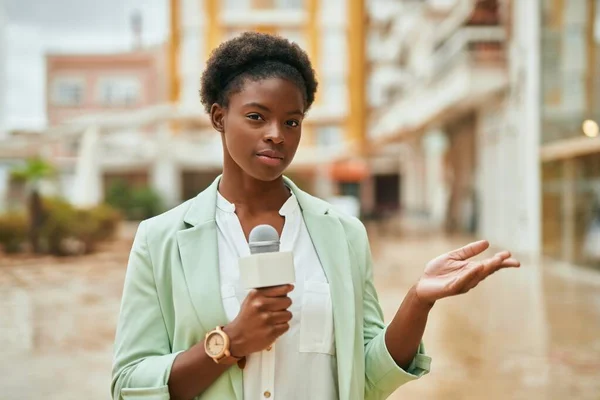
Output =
[{"x1": 11, "y1": 157, "x2": 55, "y2": 254}]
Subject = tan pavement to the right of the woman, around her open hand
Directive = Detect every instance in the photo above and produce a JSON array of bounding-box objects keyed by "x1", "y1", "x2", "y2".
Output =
[{"x1": 372, "y1": 231, "x2": 600, "y2": 400}]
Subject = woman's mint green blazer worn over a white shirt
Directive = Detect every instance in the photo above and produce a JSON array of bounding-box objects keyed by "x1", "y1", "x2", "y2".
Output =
[{"x1": 111, "y1": 177, "x2": 430, "y2": 400}]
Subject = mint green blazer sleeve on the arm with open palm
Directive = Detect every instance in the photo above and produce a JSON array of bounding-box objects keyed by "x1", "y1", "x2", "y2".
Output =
[{"x1": 357, "y1": 223, "x2": 431, "y2": 400}]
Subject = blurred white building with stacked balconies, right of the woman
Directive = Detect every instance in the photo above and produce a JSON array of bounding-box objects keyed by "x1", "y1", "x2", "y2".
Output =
[{"x1": 365, "y1": 0, "x2": 540, "y2": 253}]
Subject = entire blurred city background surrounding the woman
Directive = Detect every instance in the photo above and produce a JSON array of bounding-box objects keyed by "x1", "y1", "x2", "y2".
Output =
[{"x1": 0, "y1": 0, "x2": 600, "y2": 400}]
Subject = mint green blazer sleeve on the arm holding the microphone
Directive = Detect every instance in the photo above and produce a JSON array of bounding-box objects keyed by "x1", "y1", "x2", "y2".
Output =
[{"x1": 111, "y1": 222, "x2": 179, "y2": 400}]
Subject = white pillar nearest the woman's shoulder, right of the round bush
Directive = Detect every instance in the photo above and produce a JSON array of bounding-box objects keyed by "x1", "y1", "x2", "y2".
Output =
[{"x1": 150, "y1": 125, "x2": 182, "y2": 208}]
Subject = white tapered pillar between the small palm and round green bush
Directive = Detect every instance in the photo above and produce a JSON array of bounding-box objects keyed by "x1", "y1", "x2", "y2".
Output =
[{"x1": 71, "y1": 126, "x2": 103, "y2": 207}]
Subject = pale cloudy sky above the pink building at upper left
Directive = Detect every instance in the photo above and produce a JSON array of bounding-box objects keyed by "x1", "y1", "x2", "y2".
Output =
[{"x1": 0, "y1": 0, "x2": 168, "y2": 129}]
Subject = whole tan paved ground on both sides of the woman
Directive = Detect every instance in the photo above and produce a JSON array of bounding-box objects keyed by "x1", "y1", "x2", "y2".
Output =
[{"x1": 0, "y1": 223, "x2": 600, "y2": 400}]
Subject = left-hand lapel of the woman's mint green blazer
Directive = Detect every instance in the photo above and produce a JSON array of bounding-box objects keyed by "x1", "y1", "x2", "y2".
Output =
[{"x1": 177, "y1": 177, "x2": 243, "y2": 400}]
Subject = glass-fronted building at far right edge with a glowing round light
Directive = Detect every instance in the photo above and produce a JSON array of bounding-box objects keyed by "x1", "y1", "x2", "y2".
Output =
[{"x1": 541, "y1": 0, "x2": 600, "y2": 266}]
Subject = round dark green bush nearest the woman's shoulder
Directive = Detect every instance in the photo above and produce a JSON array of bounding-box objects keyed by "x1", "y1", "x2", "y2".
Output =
[{"x1": 106, "y1": 180, "x2": 163, "y2": 221}]
